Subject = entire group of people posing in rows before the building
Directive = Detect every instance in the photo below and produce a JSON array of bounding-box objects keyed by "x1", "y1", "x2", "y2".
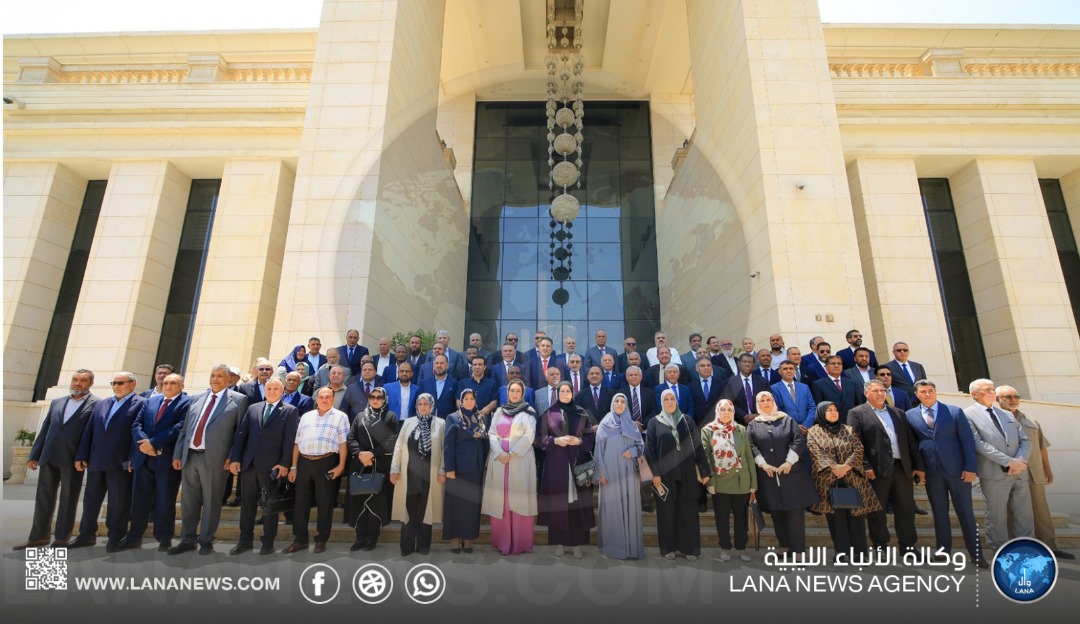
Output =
[{"x1": 16, "y1": 329, "x2": 1072, "y2": 567}]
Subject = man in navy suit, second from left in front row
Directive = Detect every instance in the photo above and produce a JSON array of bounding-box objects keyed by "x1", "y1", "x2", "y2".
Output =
[{"x1": 68, "y1": 370, "x2": 146, "y2": 554}]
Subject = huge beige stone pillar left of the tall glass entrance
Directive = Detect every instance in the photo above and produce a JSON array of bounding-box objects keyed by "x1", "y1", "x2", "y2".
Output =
[{"x1": 271, "y1": 0, "x2": 469, "y2": 353}]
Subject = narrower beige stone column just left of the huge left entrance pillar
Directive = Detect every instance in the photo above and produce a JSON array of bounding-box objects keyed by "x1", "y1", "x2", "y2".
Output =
[{"x1": 188, "y1": 160, "x2": 295, "y2": 373}]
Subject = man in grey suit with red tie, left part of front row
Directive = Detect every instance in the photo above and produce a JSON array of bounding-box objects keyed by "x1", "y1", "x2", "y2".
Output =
[{"x1": 168, "y1": 364, "x2": 247, "y2": 555}]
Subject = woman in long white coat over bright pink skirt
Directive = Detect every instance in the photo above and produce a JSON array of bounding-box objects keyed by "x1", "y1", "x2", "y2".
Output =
[{"x1": 482, "y1": 379, "x2": 537, "y2": 555}]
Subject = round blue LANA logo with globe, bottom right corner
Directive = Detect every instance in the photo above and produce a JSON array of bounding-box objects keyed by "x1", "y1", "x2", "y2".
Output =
[{"x1": 991, "y1": 538, "x2": 1057, "y2": 603}]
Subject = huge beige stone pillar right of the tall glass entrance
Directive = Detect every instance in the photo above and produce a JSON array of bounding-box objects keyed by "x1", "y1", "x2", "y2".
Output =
[{"x1": 657, "y1": 0, "x2": 869, "y2": 345}]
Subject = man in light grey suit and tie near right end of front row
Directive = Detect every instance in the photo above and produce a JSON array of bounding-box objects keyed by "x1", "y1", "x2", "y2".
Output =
[{"x1": 963, "y1": 379, "x2": 1035, "y2": 552}]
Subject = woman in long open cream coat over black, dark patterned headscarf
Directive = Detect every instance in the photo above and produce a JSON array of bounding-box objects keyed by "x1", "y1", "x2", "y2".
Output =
[{"x1": 390, "y1": 392, "x2": 446, "y2": 557}]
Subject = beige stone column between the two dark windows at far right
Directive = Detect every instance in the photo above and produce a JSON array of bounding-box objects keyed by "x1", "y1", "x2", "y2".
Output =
[{"x1": 949, "y1": 159, "x2": 1080, "y2": 403}]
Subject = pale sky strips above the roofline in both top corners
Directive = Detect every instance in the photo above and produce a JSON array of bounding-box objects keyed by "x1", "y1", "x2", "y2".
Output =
[{"x1": 0, "y1": 0, "x2": 1080, "y2": 35}]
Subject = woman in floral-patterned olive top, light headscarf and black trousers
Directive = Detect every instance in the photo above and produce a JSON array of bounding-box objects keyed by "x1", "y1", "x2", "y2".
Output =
[{"x1": 701, "y1": 398, "x2": 757, "y2": 561}]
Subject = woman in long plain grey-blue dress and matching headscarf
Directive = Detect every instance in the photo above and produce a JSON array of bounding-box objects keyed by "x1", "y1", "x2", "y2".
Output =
[{"x1": 593, "y1": 393, "x2": 645, "y2": 559}]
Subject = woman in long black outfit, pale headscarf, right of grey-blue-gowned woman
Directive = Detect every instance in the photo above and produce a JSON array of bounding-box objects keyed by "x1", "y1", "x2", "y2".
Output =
[{"x1": 645, "y1": 390, "x2": 708, "y2": 561}]
